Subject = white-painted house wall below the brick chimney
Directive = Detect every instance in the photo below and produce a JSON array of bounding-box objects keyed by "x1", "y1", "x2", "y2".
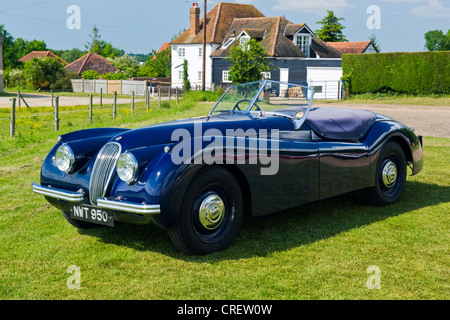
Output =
[{"x1": 172, "y1": 43, "x2": 218, "y2": 89}]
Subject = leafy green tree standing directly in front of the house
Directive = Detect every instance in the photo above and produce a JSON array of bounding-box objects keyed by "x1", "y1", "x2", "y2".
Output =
[{"x1": 226, "y1": 39, "x2": 269, "y2": 84}]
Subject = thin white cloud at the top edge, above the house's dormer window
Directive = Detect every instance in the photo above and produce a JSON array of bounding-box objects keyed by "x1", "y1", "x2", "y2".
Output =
[{"x1": 273, "y1": 0, "x2": 351, "y2": 13}]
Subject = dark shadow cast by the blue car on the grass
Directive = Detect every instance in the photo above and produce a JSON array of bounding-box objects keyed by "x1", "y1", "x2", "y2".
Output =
[{"x1": 80, "y1": 181, "x2": 450, "y2": 263}]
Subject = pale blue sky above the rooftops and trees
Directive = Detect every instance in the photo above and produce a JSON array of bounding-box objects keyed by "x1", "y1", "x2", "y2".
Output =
[{"x1": 0, "y1": 0, "x2": 450, "y2": 54}]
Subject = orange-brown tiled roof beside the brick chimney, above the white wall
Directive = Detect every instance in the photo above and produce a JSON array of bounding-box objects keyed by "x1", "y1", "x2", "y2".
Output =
[{"x1": 171, "y1": 2, "x2": 264, "y2": 44}]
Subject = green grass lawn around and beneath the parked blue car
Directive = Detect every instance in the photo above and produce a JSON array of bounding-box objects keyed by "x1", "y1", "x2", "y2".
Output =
[{"x1": 0, "y1": 97, "x2": 450, "y2": 300}]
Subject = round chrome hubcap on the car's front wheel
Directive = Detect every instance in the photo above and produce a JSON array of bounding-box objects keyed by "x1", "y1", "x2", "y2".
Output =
[{"x1": 198, "y1": 194, "x2": 225, "y2": 230}]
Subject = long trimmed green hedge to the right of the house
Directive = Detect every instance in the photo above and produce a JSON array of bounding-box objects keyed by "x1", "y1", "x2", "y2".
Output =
[{"x1": 342, "y1": 51, "x2": 450, "y2": 94}]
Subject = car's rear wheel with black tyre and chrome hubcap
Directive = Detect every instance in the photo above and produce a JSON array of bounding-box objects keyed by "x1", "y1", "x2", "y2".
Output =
[{"x1": 365, "y1": 141, "x2": 406, "y2": 206}]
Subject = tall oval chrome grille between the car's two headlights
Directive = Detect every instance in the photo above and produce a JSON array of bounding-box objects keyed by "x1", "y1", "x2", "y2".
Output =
[{"x1": 89, "y1": 142, "x2": 122, "y2": 205}]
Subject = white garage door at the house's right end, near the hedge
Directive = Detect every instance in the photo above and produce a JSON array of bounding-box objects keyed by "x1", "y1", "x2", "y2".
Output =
[{"x1": 306, "y1": 67, "x2": 342, "y2": 100}]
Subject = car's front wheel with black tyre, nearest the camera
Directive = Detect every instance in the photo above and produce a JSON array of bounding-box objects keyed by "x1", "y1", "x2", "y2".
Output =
[{"x1": 169, "y1": 167, "x2": 243, "y2": 255}]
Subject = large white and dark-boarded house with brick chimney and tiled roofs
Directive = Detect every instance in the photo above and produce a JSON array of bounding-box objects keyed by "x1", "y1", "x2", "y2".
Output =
[{"x1": 171, "y1": 2, "x2": 342, "y2": 97}]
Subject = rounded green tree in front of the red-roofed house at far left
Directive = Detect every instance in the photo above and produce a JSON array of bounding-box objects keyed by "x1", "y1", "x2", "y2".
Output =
[{"x1": 23, "y1": 58, "x2": 65, "y2": 90}]
